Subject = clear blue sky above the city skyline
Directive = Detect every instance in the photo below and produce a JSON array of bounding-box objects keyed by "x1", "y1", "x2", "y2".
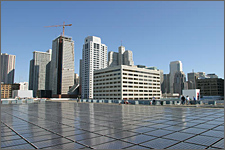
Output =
[{"x1": 1, "y1": 1, "x2": 224, "y2": 82}]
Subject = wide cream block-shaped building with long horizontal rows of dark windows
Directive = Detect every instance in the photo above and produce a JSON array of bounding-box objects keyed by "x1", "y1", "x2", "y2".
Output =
[{"x1": 94, "y1": 65, "x2": 161, "y2": 100}]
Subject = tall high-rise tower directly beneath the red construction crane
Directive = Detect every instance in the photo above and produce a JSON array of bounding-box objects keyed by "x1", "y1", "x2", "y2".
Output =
[{"x1": 50, "y1": 36, "x2": 74, "y2": 95}]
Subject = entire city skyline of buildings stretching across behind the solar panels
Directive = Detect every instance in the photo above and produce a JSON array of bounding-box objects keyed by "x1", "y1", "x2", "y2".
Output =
[{"x1": 1, "y1": 36, "x2": 224, "y2": 100}]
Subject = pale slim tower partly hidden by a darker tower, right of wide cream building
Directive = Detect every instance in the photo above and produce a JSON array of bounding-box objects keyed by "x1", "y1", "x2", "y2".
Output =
[{"x1": 170, "y1": 61, "x2": 183, "y2": 93}]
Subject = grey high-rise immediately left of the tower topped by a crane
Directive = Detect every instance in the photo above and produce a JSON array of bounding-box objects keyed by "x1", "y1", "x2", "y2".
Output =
[{"x1": 29, "y1": 49, "x2": 52, "y2": 97}]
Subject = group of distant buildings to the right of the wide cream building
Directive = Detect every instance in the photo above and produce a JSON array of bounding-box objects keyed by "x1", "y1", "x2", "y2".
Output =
[{"x1": 162, "y1": 61, "x2": 224, "y2": 97}]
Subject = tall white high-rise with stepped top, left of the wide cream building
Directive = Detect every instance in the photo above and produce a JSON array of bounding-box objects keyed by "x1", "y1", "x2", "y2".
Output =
[{"x1": 81, "y1": 36, "x2": 107, "y2": 99}]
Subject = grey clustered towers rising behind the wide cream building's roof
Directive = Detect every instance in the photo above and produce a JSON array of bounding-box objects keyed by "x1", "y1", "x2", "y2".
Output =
[{"x1": 108, "y1": 46, "x2": 134, "y2": 67}]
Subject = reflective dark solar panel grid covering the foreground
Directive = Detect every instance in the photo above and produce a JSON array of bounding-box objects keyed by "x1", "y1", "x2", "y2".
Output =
[{"x1": 1, "y1": 101, "x2": 224, "y2": 149}]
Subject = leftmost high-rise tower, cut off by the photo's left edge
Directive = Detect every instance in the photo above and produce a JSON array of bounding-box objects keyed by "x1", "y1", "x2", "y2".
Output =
[{"x1": 1, "y1": 53, "x2": 16, "y2": 84}]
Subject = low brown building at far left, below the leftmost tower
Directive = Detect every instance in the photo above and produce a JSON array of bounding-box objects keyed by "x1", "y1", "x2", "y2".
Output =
[{"x1": 1, "y1": 84, "x2": 20, "y2": 98}]
